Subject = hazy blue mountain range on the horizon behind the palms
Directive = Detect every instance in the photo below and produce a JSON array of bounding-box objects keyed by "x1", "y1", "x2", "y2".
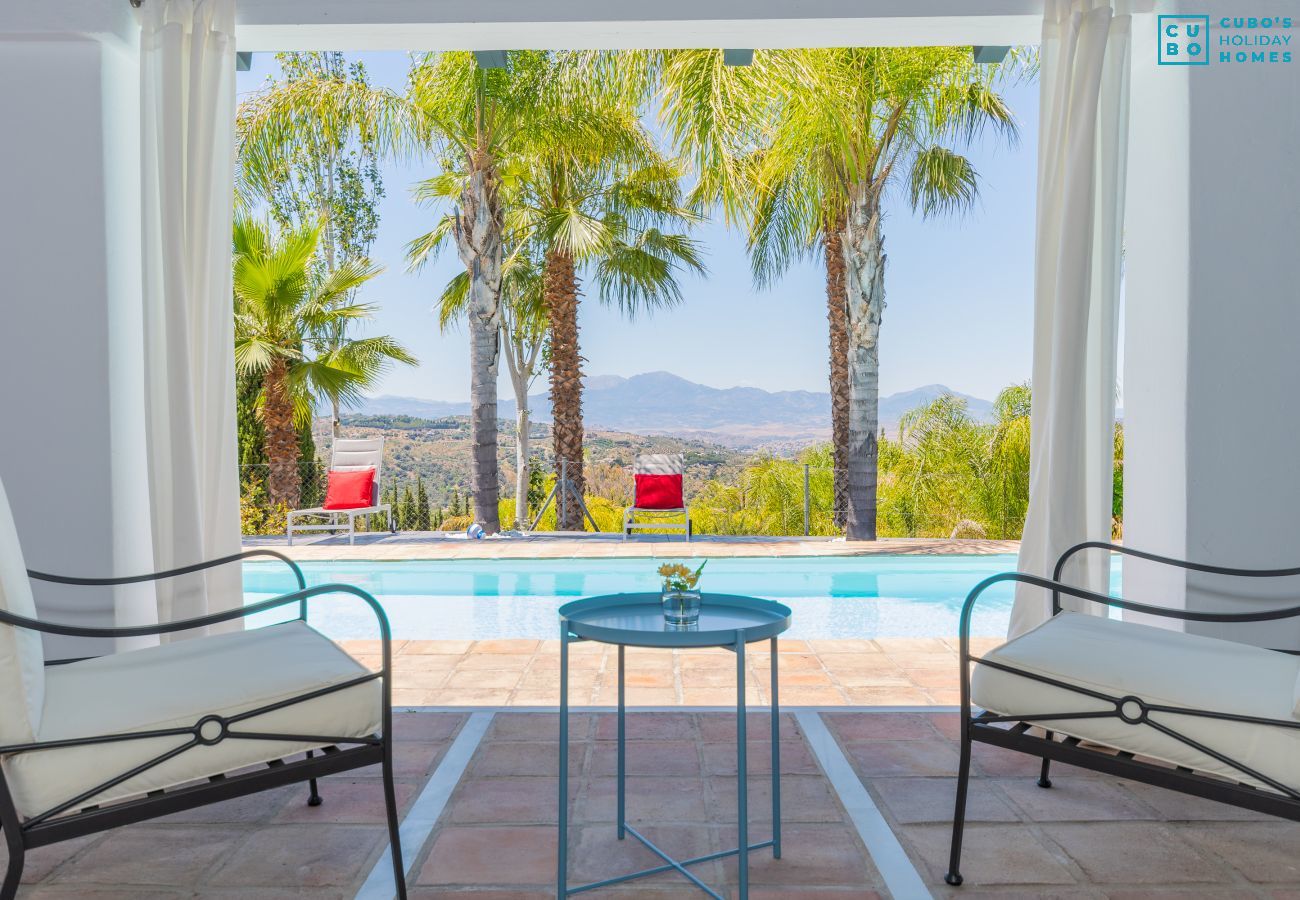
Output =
[{"x1": 352, "y1": 372, "x2": 992, "y2": 447}]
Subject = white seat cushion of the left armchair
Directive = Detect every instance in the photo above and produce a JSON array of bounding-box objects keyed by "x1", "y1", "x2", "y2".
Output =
[{"x1": 4, "y1": 622, "x2": 381, "y2": 817}]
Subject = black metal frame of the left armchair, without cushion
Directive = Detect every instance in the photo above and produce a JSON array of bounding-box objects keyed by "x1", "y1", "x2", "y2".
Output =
[{"x1": 0, "y1": 550, "x2": 406, "y2": 900}]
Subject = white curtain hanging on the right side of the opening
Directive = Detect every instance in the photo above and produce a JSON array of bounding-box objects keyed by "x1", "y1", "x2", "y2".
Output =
[{"x1": 1010, "y1": 0, "x2": 1131, "y2": 637}]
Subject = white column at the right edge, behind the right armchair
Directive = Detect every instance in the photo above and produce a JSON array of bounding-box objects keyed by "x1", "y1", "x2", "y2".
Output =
[{"x1": 1123, "y1": 0, "x2": 1300, "y2": 648}]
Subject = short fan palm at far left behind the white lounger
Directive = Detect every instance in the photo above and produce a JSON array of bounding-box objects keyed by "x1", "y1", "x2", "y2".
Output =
[{"x1": 234, "y1": 218, "x2": 415, "y2": 509}]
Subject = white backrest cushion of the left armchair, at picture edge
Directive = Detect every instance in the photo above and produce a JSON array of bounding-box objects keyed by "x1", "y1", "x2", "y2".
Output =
[{"x1": 0, "y1": 473, "x2": 46, "y2": 744}]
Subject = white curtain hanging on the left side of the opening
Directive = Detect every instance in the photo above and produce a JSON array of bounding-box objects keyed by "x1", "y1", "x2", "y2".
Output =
[{"x1": 140, "y1": 0, "x2": 243, "y2": 632}]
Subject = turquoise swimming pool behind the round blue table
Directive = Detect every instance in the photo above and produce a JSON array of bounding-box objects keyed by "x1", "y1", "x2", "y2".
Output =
[{"x1": 244, "y1": 554, "x2": 1121, "y2": 640}]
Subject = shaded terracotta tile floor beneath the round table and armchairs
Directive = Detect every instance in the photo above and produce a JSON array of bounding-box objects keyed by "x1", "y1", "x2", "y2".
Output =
[{"x1": 12, "y1": 709, "x2": 1300, "y2": 900}]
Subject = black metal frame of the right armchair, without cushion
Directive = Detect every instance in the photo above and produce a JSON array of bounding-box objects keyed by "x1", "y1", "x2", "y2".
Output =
[{"x1": 944, "y1": 541, "x2": 1300, "y2": 886}]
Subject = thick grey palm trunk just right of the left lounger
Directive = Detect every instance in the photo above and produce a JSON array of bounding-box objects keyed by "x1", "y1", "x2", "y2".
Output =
[{"x1": 454, "y1": 152, "x2": 502, "y2": 535}]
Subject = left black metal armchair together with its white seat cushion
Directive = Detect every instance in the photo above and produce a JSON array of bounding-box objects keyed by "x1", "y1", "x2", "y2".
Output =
[{"x1": 0, "y1": 551, "x2": 406, "y2": 900}]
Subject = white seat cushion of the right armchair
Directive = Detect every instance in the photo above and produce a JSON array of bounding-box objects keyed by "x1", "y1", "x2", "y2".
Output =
[{"x1": 971, "y1": 613, "x2": 1300, "y2": 788}]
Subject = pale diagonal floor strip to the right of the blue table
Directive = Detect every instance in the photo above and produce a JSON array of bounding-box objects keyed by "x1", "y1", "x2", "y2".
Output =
[{"x1": 794, "y1": 711, "x2": 932, "y2": 900}]
